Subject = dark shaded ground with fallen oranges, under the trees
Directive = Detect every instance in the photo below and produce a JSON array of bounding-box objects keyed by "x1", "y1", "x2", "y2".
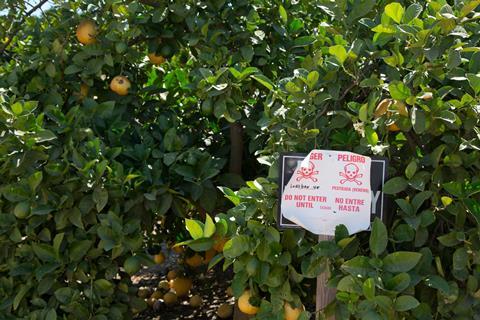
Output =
[{"x1": 132, "y1": 246, "x2": 234, "y2": 320}]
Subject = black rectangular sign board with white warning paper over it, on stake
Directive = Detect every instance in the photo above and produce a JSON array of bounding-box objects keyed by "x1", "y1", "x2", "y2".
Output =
[{"x1": 278, "y1": 150, "x2": 387, "y2": 235}]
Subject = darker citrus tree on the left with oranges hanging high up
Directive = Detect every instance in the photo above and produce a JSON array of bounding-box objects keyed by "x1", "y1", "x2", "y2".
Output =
[{"x1": 0, "y1": 1, "x2": 322, "y2": 319}]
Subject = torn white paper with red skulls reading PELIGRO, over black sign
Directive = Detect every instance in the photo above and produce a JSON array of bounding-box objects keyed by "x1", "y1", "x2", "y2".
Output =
[{"x1": 281, "y1": 150, "x2": 372, "y2": 235}]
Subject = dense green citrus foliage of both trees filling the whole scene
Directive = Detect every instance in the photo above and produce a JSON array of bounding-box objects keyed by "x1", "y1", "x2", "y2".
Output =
[{"x1": 0, "y1": 0, "x2": 480, "y2": 320}]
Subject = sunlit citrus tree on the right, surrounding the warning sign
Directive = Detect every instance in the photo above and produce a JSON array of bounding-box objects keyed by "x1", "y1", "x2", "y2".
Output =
[{"x1": 181, "y1": 1, "x2": 480, "y2": 319}]
